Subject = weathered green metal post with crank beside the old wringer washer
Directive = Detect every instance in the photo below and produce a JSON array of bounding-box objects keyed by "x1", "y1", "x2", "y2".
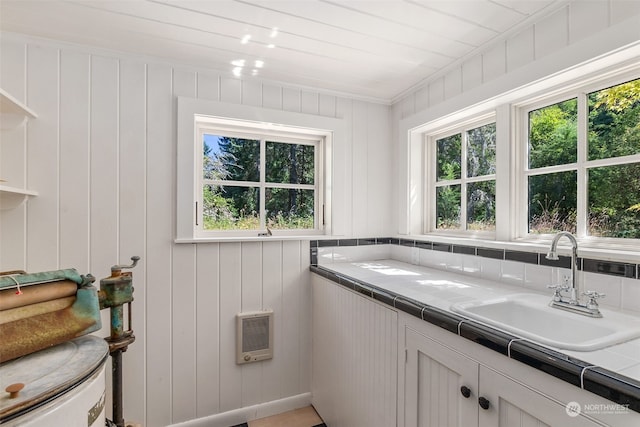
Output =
[{"x1": 98, "y1": 256, "x2": 140, "y2": 427}]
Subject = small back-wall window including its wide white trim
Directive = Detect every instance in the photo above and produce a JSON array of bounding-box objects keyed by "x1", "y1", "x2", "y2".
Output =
[{"x1": 175, "y1": 97, "x2": 338, "y2": 243}]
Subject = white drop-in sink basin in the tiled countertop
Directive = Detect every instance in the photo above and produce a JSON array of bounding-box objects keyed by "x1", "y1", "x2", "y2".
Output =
[{"x1": 451, "y1": 294, "x2": 640, "y2": 351}]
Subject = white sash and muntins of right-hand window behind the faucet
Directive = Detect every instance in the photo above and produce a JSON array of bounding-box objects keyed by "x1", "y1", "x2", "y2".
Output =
[{"x1": 512, "y1": 71, "x2": 640, "y2": 246}]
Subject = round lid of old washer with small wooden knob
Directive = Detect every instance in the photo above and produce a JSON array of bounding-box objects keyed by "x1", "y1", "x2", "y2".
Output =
[{"x1": 0, "y1": 335, "x2": 109, "y2": 424}]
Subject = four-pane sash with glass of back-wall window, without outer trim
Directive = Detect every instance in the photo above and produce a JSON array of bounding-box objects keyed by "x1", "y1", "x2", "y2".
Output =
[{"x1": 196, "y1": 123, "x2": 324, "y2": 235}]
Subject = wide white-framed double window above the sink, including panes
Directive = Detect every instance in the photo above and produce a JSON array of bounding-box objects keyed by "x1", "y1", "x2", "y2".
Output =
[{"x1": 408, "y1": 55, "x2": 640, "y2": 252}]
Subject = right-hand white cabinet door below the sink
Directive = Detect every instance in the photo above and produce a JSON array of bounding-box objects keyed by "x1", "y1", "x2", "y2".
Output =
[{"x1": 479, "y1": 365, "x2": 602, "y2": 427}]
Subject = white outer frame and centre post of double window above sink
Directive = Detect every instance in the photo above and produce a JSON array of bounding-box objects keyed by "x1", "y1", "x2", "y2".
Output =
[{"x1": 398, "y1": 45, "x2": 640, "y2": 256}]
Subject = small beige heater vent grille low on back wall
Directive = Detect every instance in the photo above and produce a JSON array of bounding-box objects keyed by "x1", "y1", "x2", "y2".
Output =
[{"x1": 236, "y1": 310, "x2": 273, "y2": 364}]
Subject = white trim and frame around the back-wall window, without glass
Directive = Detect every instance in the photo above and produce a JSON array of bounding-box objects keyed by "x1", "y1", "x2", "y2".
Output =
[{"x1": 174, "y1": 97, "x2": 346, "y2": 243}]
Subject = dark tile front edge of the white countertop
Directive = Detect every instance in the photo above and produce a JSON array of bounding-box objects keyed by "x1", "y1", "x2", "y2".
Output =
[{"x1": 310, "y1": 265, "x2": 640, "y2": 413}]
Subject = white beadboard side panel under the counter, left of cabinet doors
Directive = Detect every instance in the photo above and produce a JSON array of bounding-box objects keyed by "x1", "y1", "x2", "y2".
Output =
[{"x1": 311, "y1": 276, "x2": 398, "y2": 427}]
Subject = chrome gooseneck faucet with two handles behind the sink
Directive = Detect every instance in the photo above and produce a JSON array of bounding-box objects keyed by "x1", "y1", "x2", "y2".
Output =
[{"x1": 546, "y1": 231, "x2": 605, "y2": 317}]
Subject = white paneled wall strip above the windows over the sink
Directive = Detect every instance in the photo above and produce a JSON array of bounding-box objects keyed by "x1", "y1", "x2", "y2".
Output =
[{"x1": 394, "y1": 0, "x2": 640, "y2": 118}]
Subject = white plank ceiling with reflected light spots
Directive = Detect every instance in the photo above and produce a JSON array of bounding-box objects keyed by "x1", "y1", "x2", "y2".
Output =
[{"x1": 0, "y1": 0, "x2": 563, "y2": 101}]
